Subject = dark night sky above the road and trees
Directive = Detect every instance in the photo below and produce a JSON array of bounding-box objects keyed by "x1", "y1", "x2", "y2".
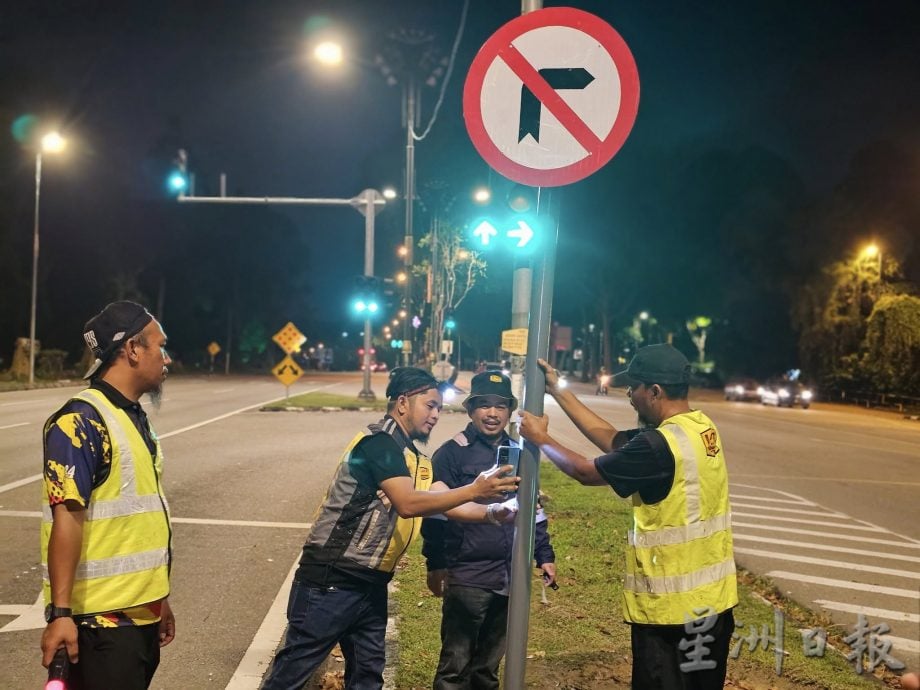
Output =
[{"x1": 0, "y1": 0, "x2": 920, "y2": 376}]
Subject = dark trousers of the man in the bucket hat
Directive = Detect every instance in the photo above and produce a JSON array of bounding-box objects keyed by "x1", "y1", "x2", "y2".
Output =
[{"x1": 434, "y1": 585, "x2": 508, "y2": 690}]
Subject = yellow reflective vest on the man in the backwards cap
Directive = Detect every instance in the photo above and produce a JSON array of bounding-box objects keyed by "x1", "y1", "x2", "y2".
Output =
[{"x1": 41, "y1": 388, "x2": 172, "y2": 615}]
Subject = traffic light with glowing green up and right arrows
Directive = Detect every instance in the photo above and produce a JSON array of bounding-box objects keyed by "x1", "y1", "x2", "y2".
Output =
[{"x1": 470, "y1": 184, "x2": 541, "y2": 253}]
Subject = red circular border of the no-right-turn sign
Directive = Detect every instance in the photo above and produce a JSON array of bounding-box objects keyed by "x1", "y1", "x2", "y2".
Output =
[{"x1": 463, "y1": 7, "x2": 639, "y2": 187}]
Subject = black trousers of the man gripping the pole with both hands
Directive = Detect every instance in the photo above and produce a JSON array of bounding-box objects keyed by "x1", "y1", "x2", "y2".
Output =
[{"x1": 631, "y1": 609, "x2": 735, "y2": 690}]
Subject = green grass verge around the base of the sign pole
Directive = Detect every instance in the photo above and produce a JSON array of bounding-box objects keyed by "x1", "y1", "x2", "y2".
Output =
[{"x1": 390, "y1": 463, "x2": 897, "y2": 690}]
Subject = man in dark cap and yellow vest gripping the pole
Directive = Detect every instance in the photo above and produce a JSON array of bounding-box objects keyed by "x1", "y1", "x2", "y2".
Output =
[{"x1": 521, "y1": 345, "x2": 738, "y2": 690}]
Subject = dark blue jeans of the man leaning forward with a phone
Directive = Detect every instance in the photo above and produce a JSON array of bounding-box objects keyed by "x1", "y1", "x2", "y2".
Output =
[{"x1": 262, "y1": 580, "x2": 387, "y2": 690}]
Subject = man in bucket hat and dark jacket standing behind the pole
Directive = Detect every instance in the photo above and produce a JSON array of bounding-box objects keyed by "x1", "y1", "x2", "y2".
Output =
[{"x1": 422, "y1": 371, "x2": 556, "y2": 690}]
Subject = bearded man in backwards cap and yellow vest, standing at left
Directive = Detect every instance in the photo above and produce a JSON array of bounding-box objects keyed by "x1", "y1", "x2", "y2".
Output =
[{"x1": 41, "y1": 301, "x2": 175, "y2": 690}]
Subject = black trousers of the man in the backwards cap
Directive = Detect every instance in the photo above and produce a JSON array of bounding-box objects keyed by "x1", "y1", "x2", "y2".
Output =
[{"x1": 67, "y1": 625, "x2": 160, "y2": 690}]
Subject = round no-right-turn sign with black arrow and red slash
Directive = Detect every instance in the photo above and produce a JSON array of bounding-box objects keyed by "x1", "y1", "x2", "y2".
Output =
[{"x1": 463, "y1": 7, "x2": 639, "y2": 187}]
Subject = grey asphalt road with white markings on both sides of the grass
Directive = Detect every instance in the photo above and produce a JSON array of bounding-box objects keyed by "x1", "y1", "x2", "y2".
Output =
[{"x1": 0, "y1": 374, "x2": 920, "y2": 690}]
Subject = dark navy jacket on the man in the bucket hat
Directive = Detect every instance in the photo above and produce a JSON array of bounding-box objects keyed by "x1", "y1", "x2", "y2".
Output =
[{"x1": 422, "y1": 423, "x2": 556, "y2": 591}]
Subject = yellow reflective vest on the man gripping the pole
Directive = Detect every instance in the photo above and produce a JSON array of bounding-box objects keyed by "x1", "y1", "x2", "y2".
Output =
[{"x1": 623, "y1": 411, "x2": 738, "y2": 625}]
